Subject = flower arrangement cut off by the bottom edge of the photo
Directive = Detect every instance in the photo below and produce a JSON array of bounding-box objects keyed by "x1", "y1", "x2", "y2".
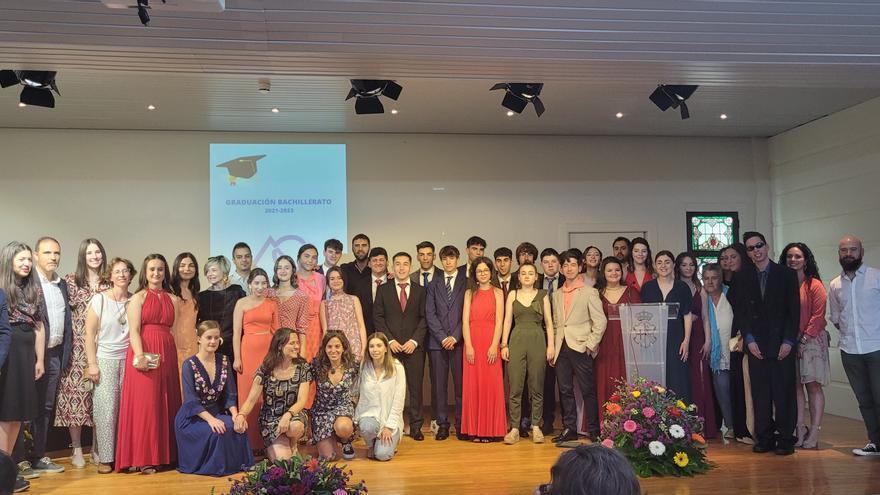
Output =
[{"x1": 229, "y1": 455, "x2": 367, "y2": 495}]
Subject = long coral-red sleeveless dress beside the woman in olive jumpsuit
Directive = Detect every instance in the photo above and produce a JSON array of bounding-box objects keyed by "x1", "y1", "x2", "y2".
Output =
[{"x1": 461, "y1": 289, "x2": 507, "y2": 438}]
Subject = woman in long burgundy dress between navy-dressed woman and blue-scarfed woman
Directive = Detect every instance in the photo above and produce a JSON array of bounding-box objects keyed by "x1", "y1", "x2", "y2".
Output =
[{"x1": 675, "y1": 253, "x2": 718, "y2": 438}]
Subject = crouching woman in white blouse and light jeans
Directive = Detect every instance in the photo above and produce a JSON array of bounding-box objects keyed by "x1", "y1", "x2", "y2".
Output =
[{"x1": 354, "y1": 332, "x2": 406, "y2": 461}]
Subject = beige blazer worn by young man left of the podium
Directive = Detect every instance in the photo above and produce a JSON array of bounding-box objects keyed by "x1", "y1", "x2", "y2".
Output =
[{"x1": 553, "y1": 286, "x2": 608, "y2": 363}]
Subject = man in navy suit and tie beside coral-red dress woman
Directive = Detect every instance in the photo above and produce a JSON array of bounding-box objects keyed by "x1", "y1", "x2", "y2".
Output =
[{"x1": 425, "y1": 246, "x2": 467, "y2": 440}]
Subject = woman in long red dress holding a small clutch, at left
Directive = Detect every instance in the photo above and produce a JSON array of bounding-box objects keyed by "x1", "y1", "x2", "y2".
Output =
[{"x1": 116, "y1": 254, "x2": 181, "y2": 474}]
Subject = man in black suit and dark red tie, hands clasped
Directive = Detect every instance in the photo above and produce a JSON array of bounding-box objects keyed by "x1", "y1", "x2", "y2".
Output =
[{"x1": 373, "y1": 252, "x2": 428, "y2": 441}]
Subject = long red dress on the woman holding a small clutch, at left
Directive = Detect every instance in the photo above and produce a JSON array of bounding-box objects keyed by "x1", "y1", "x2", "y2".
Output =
[{"x1": 116, "y1": 289, "x2": 181, "y2": 472}]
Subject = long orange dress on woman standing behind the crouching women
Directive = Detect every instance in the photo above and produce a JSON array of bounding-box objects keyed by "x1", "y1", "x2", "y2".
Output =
[{"x1": 238, "y1": 298, "x2": 281, "y2": 449}]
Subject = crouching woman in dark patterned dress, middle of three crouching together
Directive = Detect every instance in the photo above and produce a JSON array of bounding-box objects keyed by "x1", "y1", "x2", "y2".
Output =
[{"x1": 311, "y1": 330, "x2": 358, "y2": 460}]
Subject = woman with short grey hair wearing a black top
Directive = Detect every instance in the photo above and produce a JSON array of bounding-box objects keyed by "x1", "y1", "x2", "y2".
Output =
[{"x1": 196, "y1": 255, "x2": 247, "y2": 362}]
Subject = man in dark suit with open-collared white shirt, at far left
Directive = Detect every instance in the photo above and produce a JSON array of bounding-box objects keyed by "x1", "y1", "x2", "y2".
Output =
[{"x1": 17, "y1": 237, "x2": 73, "y2": 473}]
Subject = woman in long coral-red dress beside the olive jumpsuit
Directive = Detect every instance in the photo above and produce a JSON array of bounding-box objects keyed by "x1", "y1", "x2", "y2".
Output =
[{"x1": 461, "y1": 257, "x2": 507, "y2": 442}]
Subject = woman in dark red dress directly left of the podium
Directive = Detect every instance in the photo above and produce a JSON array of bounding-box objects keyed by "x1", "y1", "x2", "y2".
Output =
[{"x1": 583, "y1": 256, "x2": 642, "y2": 431}]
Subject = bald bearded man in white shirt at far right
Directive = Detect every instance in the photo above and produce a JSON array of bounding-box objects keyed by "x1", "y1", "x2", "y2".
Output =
[{"x1": 828, "y1": 236, "x2": 880, "y2": 456}]
